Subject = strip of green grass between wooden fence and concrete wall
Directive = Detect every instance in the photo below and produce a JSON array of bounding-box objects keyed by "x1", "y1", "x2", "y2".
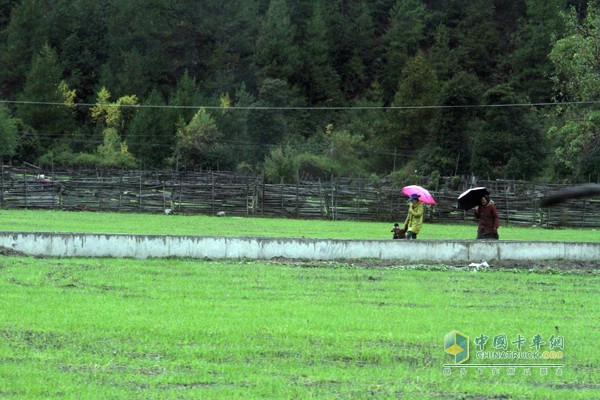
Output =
[{"x1": 0, "y1": 210, "x2": 600, "y2": 242}]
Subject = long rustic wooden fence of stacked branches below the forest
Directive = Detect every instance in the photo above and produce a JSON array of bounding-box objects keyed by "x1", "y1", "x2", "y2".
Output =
[{"x1": 0, "y1": 166, "x2": 600, "y2": 228}]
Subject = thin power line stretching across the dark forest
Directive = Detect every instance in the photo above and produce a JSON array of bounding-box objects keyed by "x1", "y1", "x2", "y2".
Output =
[{"x1": 0, "y1": 100, "x2": 600, "y2": 111}]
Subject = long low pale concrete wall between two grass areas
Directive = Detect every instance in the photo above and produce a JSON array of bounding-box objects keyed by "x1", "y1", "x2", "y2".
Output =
[{"x1": 0, "y1": 232, "x2": 600, "y2": 262}]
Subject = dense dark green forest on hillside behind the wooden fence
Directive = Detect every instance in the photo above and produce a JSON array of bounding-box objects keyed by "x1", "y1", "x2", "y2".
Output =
[{"x1": 0, "y1": 0, "x2": 600, "y2": 183}]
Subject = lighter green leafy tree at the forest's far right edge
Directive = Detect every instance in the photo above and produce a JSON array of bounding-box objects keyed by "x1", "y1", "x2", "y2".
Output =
[{"x1": 548, "y1": 2, "x2": 600, "y2": 182}]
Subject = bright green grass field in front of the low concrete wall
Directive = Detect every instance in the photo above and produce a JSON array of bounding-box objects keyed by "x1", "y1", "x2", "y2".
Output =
[{"x1": 0, "y1": 257, "x2": 600, "y2": 399}]
